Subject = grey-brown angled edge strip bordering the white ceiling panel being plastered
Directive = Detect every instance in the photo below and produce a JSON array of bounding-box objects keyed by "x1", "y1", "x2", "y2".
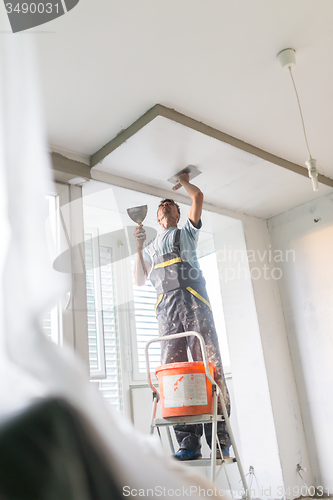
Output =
[{"x1": 90, "y1": 104, "x2": 333, "y2": 187}]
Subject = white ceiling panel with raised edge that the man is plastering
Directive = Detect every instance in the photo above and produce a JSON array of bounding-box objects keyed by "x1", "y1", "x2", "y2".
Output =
[{"x1": 94, "y1": 116, "x2": 332, "y2": 219}]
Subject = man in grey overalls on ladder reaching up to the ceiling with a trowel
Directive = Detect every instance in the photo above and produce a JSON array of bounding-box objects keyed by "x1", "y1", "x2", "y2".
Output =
[{"x1": 134, "y1": 173, "x2": 231, "y2": 460}]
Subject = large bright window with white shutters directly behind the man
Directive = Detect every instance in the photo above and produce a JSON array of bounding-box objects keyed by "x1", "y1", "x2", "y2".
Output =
[{"x1": 82, "y1": 181, "x2": 231, "y2": 406}]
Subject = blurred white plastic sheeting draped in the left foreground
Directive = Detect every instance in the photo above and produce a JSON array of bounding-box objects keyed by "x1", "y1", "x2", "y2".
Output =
[{"x1": 0, "y1": 35, "x2": 225, "y2": 498}]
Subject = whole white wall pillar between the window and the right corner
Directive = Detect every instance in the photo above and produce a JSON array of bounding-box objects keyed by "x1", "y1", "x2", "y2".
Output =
[{"x1": 215, "y1": 213, "x2": 313, "y2": 498}]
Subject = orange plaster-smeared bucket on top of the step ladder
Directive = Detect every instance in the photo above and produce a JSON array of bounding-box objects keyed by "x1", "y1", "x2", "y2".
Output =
[{"x1": 155, "y1": 361, "x2": 215, "y2": 418}]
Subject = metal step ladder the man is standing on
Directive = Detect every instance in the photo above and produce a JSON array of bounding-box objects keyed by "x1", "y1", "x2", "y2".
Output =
[{"x1": 145, "y1": 331, "x2": 251, "y2": 500}]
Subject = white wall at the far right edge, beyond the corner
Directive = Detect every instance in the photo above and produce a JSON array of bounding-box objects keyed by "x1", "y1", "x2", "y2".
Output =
[{"x1": 269, "y1": 194, "x2": 333, "y2": 493}]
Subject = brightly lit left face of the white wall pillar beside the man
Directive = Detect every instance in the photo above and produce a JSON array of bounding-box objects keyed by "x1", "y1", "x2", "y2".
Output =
[{"x1": 215, "y1": 219, "x2": 283, "y2": 498}]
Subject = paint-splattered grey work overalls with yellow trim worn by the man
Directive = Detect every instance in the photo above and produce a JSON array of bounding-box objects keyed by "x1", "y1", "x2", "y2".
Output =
[{"x1": 149, "y1": 229, "x2": 231, "y2": 451}]
